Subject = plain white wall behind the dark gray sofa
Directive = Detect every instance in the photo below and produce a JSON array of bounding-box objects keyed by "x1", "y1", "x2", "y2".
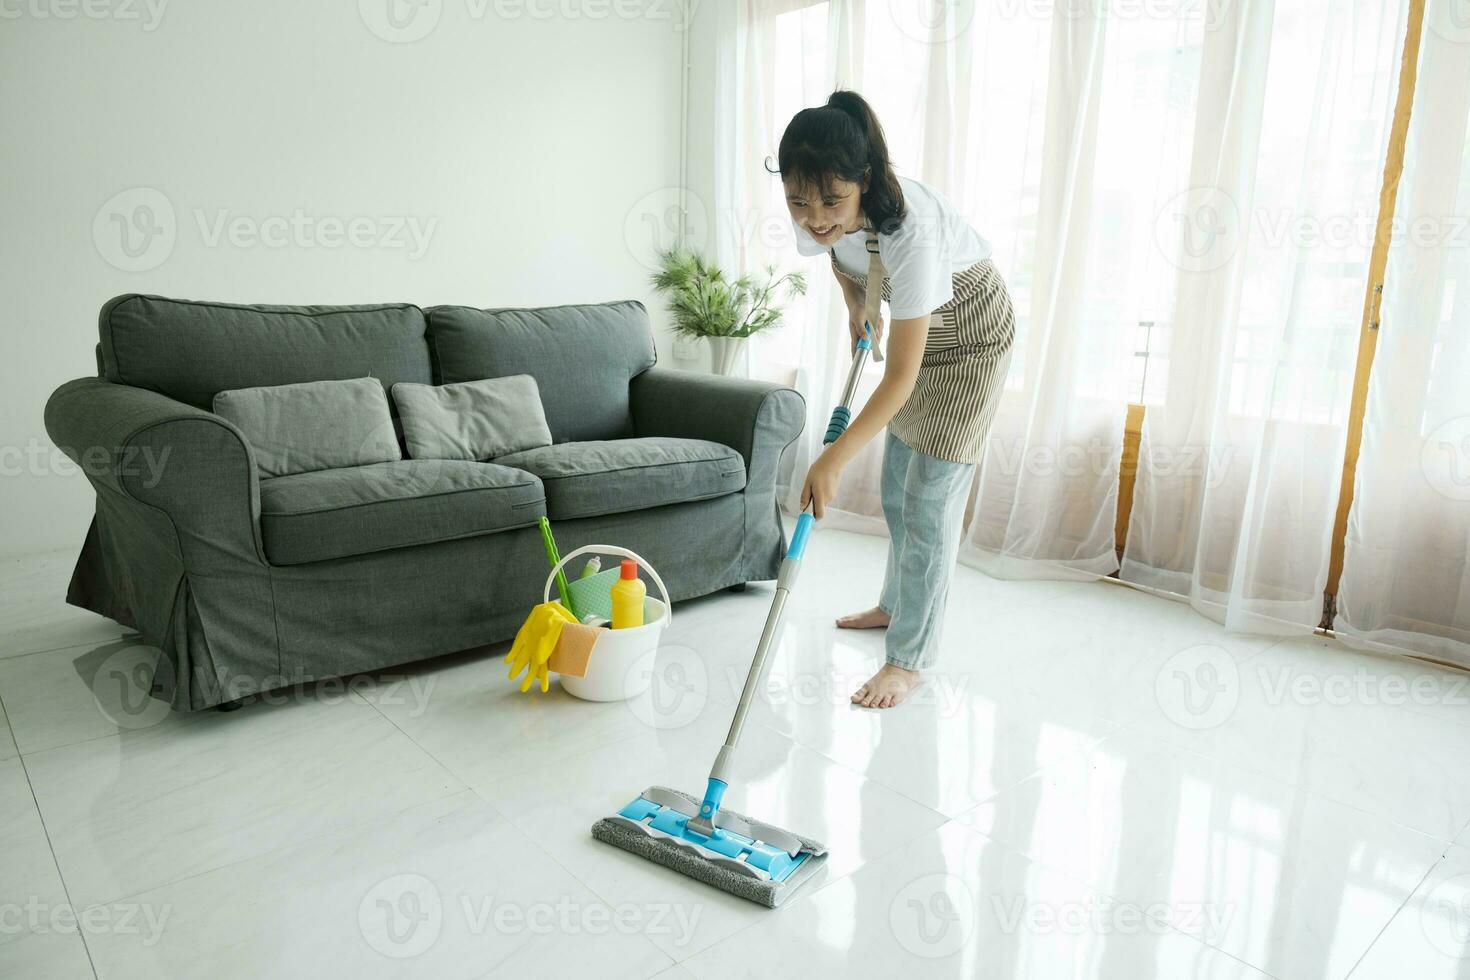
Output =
[{"x1": 0, "y1": 0, "x2": 705, "y2": 557}]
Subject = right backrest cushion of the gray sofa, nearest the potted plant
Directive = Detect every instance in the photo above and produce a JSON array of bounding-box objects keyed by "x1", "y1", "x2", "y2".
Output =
[{"x1": 428, "y1": 300, "x2": 656, "y2": 442}]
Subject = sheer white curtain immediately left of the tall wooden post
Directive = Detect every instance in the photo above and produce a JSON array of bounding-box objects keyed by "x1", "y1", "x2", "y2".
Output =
[{"x1": 1122, "y1": 0, "x2": 1407, "y2": 633}]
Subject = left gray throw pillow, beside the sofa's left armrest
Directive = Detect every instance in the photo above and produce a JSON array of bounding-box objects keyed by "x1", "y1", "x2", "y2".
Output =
[{"x1": 215, "y1": 378, "x2": 403, "y2": 476}]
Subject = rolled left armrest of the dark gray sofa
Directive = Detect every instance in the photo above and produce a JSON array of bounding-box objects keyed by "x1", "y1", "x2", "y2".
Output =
[{"x1": 46, "y1": 378, "x2": 265, "y2": 563}]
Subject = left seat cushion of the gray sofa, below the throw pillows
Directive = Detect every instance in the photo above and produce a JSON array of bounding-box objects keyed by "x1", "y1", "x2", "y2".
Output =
[{"x1": 260, "y1": 460, "x2": 545, "y2": 564}]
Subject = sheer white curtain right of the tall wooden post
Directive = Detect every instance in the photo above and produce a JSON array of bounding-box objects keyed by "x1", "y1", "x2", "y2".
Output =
[{"x1": 1335, "y1": 0, "x2": 1470, "y2": 666}]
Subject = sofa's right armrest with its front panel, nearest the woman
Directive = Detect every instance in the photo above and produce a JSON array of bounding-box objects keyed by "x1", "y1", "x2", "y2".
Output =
[{"x1": 629, "y1": 367, "x2": 807, "y2": 585}]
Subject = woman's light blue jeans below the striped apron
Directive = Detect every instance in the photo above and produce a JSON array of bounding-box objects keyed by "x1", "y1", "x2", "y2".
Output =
[{"x1": 878, "y1": 432, "x2": 975, "y2": 670}]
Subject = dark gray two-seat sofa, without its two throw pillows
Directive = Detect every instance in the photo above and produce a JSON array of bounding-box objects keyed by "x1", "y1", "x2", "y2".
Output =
[{"x1": 46, "y1": 294, "x2": 806, "y2": 711}]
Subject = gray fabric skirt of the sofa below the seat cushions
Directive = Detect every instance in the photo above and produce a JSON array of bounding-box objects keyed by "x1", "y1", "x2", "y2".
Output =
[{"x1": 66, "y1": 492, "x2": 785, "y2": 711}]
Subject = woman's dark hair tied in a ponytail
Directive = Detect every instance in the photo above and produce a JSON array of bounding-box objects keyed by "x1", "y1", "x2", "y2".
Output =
[{"x1": 767, "y1": 88, "x2": 907, "y2": 235}]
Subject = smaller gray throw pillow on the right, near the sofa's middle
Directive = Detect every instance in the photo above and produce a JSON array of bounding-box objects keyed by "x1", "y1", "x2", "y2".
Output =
[{"x1": 392, "y1": 375, "x2": 551, "y2": 460}]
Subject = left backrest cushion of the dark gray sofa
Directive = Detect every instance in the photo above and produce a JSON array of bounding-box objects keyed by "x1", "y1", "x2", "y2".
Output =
[{"x1": 97, "y1": 294, "x2": 431, "y2": 408}]
